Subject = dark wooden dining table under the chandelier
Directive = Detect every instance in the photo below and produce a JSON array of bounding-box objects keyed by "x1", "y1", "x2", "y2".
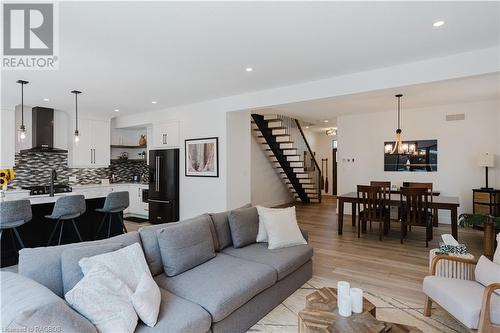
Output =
[{"x1": 337, "y1": 192, "x2": 460, "y2": 240}]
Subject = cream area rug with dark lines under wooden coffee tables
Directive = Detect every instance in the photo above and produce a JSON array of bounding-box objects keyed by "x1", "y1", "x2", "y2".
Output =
[{"x1": 248, "y1": 277, "x2": 468, "y2": 333}]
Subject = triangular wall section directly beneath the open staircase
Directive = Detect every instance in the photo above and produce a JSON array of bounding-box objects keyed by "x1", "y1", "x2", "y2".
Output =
[{"x1": 251, "y1": 128, "x2": 293, "y2": 207}]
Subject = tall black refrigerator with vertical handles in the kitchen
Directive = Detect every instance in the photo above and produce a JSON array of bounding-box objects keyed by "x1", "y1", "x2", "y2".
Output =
[{"x1": 148, "y1": 149, "x2": 179, "y2": 224}]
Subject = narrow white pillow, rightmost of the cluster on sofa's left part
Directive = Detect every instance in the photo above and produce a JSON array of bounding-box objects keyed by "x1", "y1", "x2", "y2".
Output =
[{"x1": 132, "y1": 272, "x2": 161, "y2": 327}]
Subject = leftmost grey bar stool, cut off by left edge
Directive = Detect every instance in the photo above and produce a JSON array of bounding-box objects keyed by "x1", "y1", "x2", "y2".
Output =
[{"x1": 0, "y1": 200, "x2": 32, "y2": 249}]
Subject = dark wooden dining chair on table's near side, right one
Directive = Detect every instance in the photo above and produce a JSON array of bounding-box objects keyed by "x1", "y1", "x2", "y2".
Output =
[{"x1": 400, "y1": 187, "x2": 433, "y2": 247}]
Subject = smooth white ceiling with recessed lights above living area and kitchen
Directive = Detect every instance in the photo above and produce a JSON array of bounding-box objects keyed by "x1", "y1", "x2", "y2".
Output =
[{"x1": 1, "y1": 2, "x2": 500, "y2": 116}]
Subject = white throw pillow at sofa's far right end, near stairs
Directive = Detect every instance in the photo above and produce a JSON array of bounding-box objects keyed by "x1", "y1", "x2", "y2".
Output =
[{"x1": 262, "y1": 207, "x2": 307, "y2": 250}]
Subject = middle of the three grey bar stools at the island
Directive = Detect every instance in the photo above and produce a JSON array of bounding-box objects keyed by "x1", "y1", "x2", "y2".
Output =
[{"x1": 45, "y1": 194, "x2": 86, "y2": 246}]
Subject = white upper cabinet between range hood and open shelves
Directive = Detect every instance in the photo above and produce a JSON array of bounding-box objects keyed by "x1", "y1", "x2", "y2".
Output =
[{"x1": 68, "y1": 118, "x2": 110, "y2": 168}]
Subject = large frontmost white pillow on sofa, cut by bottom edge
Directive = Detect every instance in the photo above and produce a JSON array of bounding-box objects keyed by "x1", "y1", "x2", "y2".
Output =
[{"x1": 65, "y1": 264, "x2": 138, "y2": 333}]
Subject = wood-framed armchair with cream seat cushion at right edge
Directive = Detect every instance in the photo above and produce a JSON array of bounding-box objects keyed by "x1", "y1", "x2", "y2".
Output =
[{"x1": 423, "y1": 255, "x2": 500, "y2": 333}]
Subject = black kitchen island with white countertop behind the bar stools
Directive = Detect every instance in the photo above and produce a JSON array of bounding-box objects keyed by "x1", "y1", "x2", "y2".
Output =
[{"x1": 0, "y1": 183, "x2": 148, "y2": 267}]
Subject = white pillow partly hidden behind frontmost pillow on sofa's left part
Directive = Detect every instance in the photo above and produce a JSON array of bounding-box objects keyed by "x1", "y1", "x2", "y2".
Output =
[{"x1": 78, "y1": 243, "x2": 151, "y2": 292}]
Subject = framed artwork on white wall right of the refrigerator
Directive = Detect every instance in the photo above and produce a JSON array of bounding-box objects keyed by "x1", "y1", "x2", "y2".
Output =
[{"x1": 184, "y1": 137, "x2": 219, "y2": 177}]
